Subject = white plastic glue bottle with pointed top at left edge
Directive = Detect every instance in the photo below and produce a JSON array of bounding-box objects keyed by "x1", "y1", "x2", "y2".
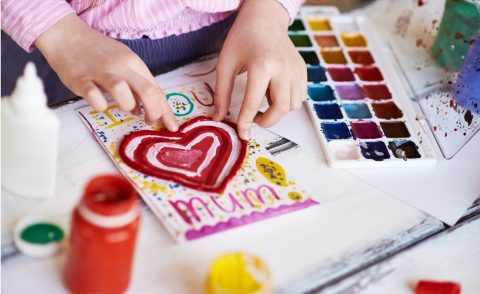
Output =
[{"x1": 1, "y1": 62, "x2": 60, "y2": 198}]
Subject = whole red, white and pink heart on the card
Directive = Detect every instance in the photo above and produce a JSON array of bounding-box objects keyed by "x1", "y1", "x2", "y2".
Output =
[{"x1": 119, "y1": 116, "x2": 247, "y2": 193}]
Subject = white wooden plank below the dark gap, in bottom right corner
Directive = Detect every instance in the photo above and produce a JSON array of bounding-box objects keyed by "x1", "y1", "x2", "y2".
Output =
[{"x1": 325, "y1": 211, "x2": 480, "y2": 293}]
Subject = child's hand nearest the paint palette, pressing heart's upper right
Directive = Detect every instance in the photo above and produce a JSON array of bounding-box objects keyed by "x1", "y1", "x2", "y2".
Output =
[{"x1": 214, "y1": 0, "x2": 307, "y2": 139}]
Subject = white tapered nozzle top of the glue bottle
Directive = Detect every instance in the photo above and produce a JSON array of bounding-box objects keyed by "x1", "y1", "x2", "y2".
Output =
[{"x1": 10, "y1": 62, "x2": 47, "y2": 111}]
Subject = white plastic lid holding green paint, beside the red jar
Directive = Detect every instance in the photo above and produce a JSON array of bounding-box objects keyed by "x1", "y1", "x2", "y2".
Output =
[{"x1": 13, "y1": 216, "x2": 67, "y2": 258}]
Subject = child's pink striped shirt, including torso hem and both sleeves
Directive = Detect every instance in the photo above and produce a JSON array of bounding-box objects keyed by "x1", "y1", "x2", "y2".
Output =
[{"x1": 2, "y1": 0, "x2": 303, "y2": 51}]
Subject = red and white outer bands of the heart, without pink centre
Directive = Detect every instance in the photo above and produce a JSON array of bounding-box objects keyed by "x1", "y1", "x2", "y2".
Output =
[{"x1": 119, "y1": 116, "x2": 247, "y2": 193}]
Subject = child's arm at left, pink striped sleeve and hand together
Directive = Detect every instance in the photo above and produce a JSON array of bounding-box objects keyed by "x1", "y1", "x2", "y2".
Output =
[{"x1": 2, "y1": 0, "x2": 178, "y2": 131}]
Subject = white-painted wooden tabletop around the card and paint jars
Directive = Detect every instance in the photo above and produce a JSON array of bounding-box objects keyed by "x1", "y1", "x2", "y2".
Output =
[{"x1": 1, "y1": 1, "x2": 480, "y2": 294}]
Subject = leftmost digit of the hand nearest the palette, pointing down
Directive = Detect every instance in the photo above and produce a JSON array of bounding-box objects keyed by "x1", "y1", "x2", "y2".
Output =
[{"x1": 213, "y1": 62, "x2": 237, "y2": 121}]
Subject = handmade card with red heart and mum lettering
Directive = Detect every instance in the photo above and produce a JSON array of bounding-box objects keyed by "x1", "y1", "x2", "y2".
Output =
[{"x1": 78, "y1": 82, "x2": 318, "y2": 240}]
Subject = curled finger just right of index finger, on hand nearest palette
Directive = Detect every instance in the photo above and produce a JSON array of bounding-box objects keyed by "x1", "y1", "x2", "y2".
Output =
[{"x1": 255, "y1": 76, "x2": 293, "y2": 128}]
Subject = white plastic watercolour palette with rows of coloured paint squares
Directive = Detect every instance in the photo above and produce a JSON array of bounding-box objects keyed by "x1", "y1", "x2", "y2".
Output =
[{"x1": 289, "y1": 8, "x2": 436, "y2": 168}]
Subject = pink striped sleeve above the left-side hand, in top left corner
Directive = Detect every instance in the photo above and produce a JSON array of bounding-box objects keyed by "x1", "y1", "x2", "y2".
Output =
[{"x1": 2, "y1": 0, "x2": 75, "y2": 52}]
